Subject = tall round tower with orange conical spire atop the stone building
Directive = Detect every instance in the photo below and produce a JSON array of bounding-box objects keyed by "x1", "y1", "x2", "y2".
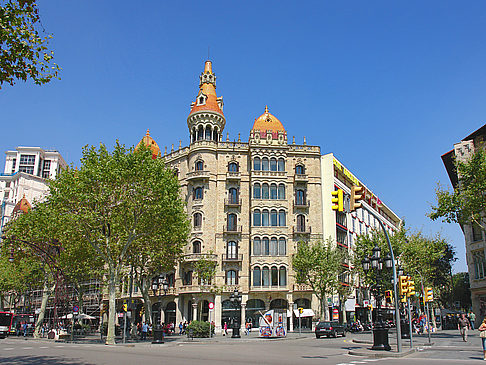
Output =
[{"x1": 187, "y1": 60, "x2": 226, "y2": 143}]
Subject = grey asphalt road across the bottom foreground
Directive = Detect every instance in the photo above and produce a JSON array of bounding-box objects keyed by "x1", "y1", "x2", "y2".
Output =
[{"x1": 0, "y1": 333, "x2": 482, "y2": 365}]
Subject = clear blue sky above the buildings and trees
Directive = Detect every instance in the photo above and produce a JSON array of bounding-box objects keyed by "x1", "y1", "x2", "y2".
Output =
[{"x1": 0, "y1": 0, "x2": 486, "y2": 271}]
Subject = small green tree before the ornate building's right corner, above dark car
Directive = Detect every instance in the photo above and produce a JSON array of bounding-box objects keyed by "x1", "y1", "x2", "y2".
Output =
[{"x1": 292, "y1": 240, "x2": 348, "y2": 315}]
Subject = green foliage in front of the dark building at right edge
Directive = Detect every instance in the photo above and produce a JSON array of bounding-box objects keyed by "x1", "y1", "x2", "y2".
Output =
[{"x1": 428, "y1": 146, "x2": 486, "y2": 230}]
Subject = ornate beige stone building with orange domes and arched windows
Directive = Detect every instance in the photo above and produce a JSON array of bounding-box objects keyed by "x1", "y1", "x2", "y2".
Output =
[{"x1": 131, "y1": 61, "x2": 322, "y2": 331}]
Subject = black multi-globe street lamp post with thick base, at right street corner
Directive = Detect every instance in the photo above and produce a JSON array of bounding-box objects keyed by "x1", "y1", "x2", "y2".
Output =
[{"x1": 361, "y1": 246, "x2": 393, "y2": 351}]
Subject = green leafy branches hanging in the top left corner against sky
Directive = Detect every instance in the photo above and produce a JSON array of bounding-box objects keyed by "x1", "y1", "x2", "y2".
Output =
[{"x1": 0, "y1": 0, "x2": 60, "y2": 88}]
